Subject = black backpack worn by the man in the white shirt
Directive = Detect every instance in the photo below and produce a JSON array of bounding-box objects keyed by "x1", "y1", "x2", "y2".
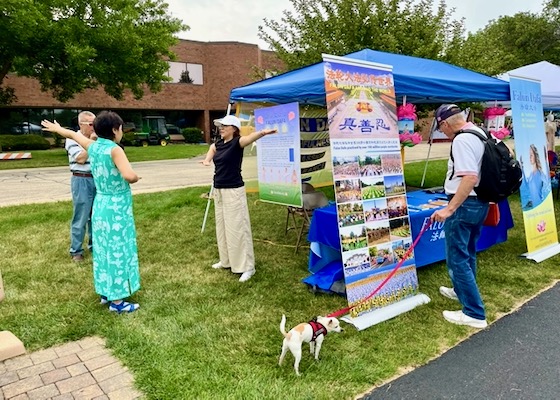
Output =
[{"x1": 451, "y1": 129, "x2": 523, "y2": 203}]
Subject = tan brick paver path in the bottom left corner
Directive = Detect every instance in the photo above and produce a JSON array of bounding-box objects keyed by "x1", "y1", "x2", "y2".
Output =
[{"x1": 0, "y1": 337, "x2": 142, "y2": 400}]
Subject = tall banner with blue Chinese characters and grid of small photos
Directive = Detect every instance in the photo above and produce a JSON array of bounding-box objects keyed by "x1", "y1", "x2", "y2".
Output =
[{"x1": 323, "y1": 55, "x2": 418, "y2": 318}]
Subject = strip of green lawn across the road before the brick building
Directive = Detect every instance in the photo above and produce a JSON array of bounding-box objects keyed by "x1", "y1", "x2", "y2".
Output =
[{"x1": 0, "y1": 144, "x2": 208, "y2": 170}]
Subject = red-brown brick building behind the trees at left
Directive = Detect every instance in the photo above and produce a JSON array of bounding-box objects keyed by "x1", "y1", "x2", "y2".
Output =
[{"x1": 0, "y1": 40, "x2": 281, "y2": 141}]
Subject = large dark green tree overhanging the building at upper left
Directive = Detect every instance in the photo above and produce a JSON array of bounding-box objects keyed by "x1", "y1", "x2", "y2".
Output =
[{"x1": 0, "y1": 0, "x2": 188, "y2": 104}]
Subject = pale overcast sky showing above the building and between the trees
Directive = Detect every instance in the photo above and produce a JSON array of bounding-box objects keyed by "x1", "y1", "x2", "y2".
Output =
[{"x1": 166, "y1": 0, "x2": 542, "y2": 49}]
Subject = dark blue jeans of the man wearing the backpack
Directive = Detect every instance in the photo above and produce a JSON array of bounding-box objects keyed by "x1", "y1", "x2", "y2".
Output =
[{"x1": 443, "y1": 197, "x2": 488, "y2": 319}]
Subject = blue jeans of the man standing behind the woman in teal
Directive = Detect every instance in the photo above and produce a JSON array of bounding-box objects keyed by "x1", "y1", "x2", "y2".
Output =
[{"x1": 70, "y1": 175, "x2": 95, "y2": 256}]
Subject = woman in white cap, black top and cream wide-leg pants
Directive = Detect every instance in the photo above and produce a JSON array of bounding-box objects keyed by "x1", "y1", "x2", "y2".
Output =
[{"x1": 202, "y1": 115, "x2": 276, "y2": 282}]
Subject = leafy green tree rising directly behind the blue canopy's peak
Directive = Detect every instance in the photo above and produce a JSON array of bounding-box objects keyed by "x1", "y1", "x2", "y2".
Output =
[{"x1": 259, "y1": 0, "x2": 464, "y2": 69}]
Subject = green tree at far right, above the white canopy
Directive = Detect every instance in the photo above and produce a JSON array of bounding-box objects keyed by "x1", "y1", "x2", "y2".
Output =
[{"x1": 452, "y1": 12, "x2": 560, "y2": 75}]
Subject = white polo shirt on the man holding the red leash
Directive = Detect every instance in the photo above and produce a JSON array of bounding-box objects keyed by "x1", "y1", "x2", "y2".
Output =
[{"x1": 444, "y1": 122, "x2": 486, "y2": 196}]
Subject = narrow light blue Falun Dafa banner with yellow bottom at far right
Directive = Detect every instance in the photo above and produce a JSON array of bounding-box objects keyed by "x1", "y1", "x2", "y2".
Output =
[{"x1": 509, "y1": 75, "x2": 558, "y2": 253}]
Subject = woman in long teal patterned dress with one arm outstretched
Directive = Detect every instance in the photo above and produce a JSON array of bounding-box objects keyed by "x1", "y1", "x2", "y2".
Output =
[{"x1": 41, "y1": 111, "x2": 140, "y2": 313}]
